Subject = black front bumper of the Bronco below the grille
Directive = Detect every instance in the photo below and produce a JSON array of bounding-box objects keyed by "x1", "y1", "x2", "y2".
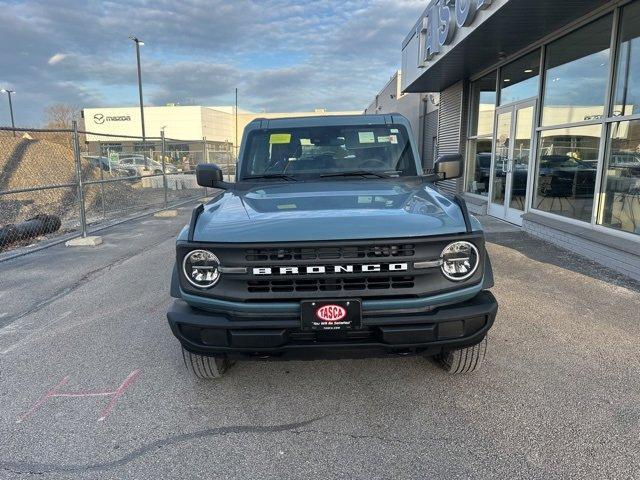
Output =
[{"x1": 167, "y1": 291, "x2": 498, "y2": 358}]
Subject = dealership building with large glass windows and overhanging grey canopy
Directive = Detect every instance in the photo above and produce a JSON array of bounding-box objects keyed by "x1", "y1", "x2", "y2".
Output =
[{"x1": 401, "y1": 0, "x2": 640, "y2": 279}]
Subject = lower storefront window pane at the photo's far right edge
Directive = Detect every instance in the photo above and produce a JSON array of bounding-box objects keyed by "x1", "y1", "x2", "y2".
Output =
[{"x1": 598, "y1": 120, "x2": 640, "y2": 234}]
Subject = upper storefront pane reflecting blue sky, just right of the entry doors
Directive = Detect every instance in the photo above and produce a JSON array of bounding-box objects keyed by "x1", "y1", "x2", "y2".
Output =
[{"x1": 542, "y1": 15, "x2": 613, "y2": 126}]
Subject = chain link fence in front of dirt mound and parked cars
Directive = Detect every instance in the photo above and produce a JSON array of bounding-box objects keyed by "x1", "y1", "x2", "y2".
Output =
[{"x1": 0, "y1": 124, "x2": 235, "y2": 253}]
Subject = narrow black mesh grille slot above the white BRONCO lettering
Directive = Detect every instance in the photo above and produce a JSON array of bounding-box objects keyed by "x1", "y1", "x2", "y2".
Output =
[{"x1": 245, "y1": 244, "x2": 415, "y2": 262}]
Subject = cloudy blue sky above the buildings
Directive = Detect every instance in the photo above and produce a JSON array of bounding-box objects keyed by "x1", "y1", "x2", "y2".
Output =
[{"x1": 0, "y1": 0, "x2": 428, "y2": 127}]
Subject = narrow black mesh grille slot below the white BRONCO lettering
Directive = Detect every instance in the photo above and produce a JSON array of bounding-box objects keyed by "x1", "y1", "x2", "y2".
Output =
[{"x1": 247, "y1": 276, "x2": 415, "y2": 293}]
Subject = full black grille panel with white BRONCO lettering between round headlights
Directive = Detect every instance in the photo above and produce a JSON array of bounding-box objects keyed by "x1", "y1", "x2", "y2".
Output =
[{"x1": 177, "y1": 234, "x2": 484, "y2": 302}]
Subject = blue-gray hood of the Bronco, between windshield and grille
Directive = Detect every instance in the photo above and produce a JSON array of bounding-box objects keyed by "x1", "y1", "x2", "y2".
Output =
[{"x1": 194, "y1": 179, "x2": 465, "y2": 243}]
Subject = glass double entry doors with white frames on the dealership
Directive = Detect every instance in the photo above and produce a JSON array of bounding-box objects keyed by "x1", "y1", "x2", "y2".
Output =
[{"x1": 489, "y1": 100, "x2": 536, "y2": 225}]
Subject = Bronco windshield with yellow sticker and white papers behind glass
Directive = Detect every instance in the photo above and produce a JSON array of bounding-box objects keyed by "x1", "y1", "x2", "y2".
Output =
[{"x1": 242, "y1": 125, "x2": 417, "y2": 180}]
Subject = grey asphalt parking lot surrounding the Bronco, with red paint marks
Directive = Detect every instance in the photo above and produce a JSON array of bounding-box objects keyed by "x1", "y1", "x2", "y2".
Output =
[{"x1": 0, "y1": 209, "x2": 640, "y2": 479}]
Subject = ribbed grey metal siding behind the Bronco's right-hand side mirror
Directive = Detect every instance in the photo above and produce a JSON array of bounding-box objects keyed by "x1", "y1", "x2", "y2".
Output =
[{"x1": 436, "y1": 82, "x2": 464, "y2": 194}]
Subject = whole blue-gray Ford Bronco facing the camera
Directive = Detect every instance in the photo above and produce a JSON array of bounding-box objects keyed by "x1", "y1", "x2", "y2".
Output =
[{"x1": 167, "y1": 114, "x2": 498, "y2": 378}]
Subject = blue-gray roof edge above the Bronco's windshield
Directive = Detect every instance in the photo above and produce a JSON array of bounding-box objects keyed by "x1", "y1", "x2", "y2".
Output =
[{"x1": 247, "y1": 113, "x2": 408, "y2": 128}]
